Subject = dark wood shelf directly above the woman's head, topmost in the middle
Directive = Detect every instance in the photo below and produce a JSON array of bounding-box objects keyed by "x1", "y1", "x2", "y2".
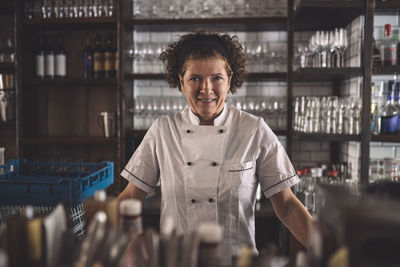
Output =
[{"x1": 125, "y1": 17, "x2": 287, "y2": 31}]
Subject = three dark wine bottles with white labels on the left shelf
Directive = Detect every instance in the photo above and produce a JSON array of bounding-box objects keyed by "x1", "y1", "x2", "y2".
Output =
[{"x1": 35, "y1": 35, "x2": 67, "y2": 79}]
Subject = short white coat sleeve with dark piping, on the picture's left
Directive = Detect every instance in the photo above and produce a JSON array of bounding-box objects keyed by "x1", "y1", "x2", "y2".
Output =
[{"x1": 121, "y1": 119, "x2": 160, "y2": 193}]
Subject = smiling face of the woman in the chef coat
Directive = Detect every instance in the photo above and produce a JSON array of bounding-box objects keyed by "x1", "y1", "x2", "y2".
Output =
[{"x1": 179, "y1": 57, "x2": 231, "y2": 124}]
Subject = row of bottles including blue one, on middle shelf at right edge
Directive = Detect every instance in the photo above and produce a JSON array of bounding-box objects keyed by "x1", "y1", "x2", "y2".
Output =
[{"x1": 371, "y1": 80, "x2": 400, "y2": 135}]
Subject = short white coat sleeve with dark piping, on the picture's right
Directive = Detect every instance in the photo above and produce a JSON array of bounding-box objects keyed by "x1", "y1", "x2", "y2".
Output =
[{"x1": 257, "y1": 119, "x2": 300, "y2": 198}]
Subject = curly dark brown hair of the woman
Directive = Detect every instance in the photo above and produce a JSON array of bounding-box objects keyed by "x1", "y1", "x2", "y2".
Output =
[{"x1": 159, "y1": 31, "x2": 247, "y2": 93}]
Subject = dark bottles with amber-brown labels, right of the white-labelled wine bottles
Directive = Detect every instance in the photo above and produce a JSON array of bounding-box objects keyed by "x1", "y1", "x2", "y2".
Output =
[{"x1": 83, "y1": 35, "x2": 118, "y2": 78}]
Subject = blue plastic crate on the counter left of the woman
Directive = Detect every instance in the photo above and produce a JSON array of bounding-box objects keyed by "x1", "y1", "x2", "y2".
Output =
[{"x1": 0, "y1": 159, "x2": 114, "y2": 207}]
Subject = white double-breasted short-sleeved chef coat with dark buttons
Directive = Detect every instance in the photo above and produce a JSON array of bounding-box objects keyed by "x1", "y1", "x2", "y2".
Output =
[{"x1": 121, "y1": 105, "x2": 299, "y2": 265}]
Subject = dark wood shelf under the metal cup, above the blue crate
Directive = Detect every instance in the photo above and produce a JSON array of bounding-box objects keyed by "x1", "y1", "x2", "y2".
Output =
[{"x1": 22, "y1": 136, "x2": 117, "y2": 145}]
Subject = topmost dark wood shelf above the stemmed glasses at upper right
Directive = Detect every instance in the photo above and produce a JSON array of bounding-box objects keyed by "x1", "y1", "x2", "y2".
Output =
[{"x1": 294, "y1": 0, "x2": 363, "y2": 31}]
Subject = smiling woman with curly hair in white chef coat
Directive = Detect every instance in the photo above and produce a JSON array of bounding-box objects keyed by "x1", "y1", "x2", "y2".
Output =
[{"x1": 119, "y1": 32, "x2": 312, "y2": 265}]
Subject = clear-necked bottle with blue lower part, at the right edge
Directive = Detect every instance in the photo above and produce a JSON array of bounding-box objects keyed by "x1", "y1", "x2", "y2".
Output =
[{"x1": 381, "y1": 81, "x2": 399, "y2": 134}]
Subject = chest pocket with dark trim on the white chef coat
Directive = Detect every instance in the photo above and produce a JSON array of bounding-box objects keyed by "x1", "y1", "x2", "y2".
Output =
[{"x1": 225, "y1": 161, "x2": 257, "y2": 188}]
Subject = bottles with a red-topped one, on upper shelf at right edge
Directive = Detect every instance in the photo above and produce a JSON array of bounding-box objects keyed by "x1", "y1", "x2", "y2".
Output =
[{"x1": 372, "y1": 24, "x2": 400, "y2": 67}]
